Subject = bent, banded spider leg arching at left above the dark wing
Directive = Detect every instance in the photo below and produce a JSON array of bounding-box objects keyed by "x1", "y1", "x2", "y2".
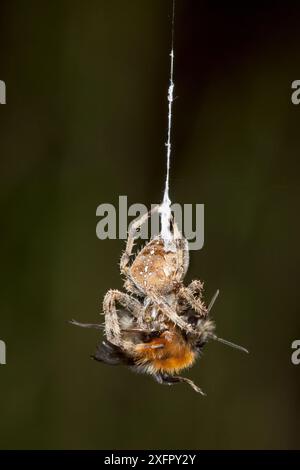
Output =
[{"x1": 103, "y1": 290, "x2": 141, "y2": 346}]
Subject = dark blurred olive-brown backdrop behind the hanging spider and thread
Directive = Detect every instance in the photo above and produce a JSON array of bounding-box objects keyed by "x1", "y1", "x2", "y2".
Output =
[{"x1": 0, "y1": 0, "x2": 300, "y2": 449}]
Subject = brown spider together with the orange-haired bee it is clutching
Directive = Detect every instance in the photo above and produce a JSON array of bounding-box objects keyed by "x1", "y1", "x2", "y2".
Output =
[{"x1": 71, "y1": 206, "x2": 248, "y2": 395}]
